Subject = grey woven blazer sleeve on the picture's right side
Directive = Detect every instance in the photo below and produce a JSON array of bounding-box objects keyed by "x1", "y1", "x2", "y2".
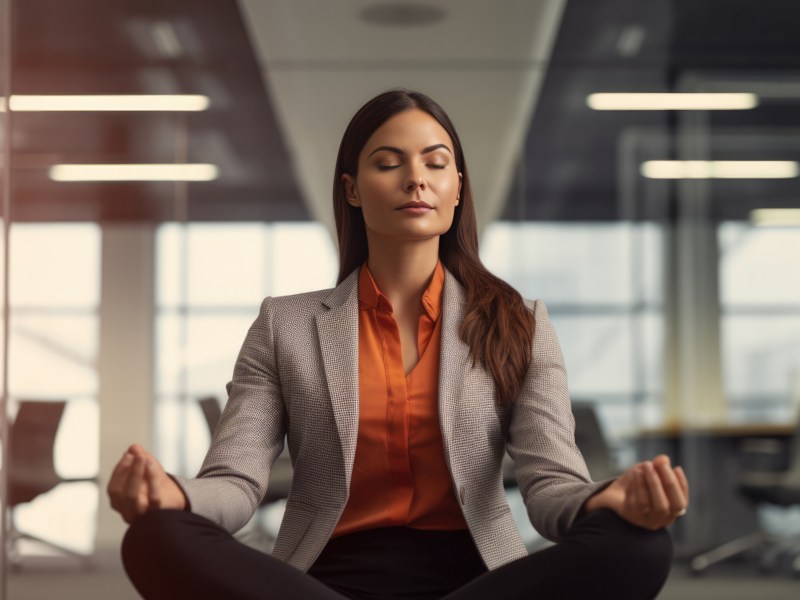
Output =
[{"x1": 507, "y1": 300, "x2": 610, "y2": 541}]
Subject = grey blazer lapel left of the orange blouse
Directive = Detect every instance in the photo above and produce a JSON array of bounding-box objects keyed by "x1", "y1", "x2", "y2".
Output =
[{"x1": 317, "y1": 269, "x2": 359, "y2": 487}]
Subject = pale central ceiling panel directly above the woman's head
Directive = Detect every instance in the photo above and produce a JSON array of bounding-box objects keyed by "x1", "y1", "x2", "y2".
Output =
[{"x1": 240, "y1": 0, "x2": 565, "y2": 233}]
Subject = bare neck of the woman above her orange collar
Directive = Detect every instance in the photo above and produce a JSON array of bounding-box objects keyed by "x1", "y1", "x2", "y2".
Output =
[{"x1": 367, "y1": 236, "x2": 439, "y2": 310}]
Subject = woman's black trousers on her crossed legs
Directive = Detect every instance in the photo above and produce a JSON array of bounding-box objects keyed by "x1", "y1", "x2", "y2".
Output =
[{"x1": 122, "y1": 510, "x2": 672, "y2": 600}]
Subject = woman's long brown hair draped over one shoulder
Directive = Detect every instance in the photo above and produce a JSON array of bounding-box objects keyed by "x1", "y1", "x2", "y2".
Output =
[{"x1": 333, "y1": 89, "x2": 534, "y2": 405}]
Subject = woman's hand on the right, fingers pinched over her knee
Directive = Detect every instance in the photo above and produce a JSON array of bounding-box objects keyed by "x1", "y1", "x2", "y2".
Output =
[{"x1": 584, "y1": 454, "x2": 689, "y2": 530}]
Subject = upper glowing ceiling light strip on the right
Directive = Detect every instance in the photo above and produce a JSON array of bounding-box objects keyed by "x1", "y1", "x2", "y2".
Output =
[{"x1": 586, "y1": 93, "x2": 758, "y2": 110}]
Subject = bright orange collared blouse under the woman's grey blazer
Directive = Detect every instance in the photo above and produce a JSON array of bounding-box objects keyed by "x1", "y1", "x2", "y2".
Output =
[{"x1": 333, "y1": 262, "x2": 467, "y2": 537}]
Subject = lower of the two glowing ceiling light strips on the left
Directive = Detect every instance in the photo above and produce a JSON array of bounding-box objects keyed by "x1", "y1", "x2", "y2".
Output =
[{"x1": 48, "y1": 163, "x2": 219, "y2": 181}]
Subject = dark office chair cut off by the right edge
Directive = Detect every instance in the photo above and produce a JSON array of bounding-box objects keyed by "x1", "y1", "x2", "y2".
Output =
[{"x1": 690, "y1": 424, "x2": 800, "y2": 576}]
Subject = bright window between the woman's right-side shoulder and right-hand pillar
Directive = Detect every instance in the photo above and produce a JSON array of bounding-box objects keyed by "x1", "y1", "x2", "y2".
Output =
[{"x1": 481, "y1": 222, "x2": 663, "y2": 438}]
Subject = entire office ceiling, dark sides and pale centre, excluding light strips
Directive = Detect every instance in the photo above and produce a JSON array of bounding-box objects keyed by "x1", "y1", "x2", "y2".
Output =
[{"x1": 8, "y1": 0, "x2": 800, "y2": 223}]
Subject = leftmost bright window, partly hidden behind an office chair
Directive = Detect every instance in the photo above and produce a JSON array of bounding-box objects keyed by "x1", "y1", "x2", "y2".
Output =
[{"x1": 8, "y1": 223, "x2": 101, "y2": 552}]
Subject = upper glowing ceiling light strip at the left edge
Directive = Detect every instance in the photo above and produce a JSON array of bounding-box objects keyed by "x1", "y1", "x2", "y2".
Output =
[{"x1": 9, "y1": 94, "x2": 211, "y2": 112}]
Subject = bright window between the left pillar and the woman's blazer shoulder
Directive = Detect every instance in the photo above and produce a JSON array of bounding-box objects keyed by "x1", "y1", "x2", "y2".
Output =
[{"x1": 155, "y1": 222, "x2": 337, "y2": 474}]
